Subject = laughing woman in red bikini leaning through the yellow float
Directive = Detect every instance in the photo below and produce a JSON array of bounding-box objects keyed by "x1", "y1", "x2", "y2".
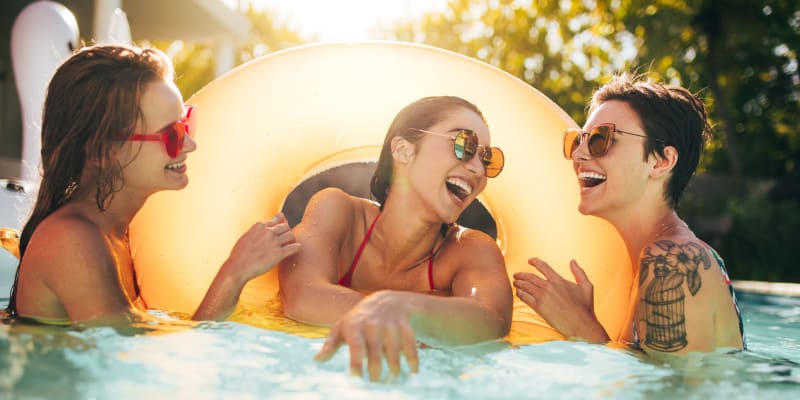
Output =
[{"x1": 279, "y1": 96, "x2": 513, "y2": 380}]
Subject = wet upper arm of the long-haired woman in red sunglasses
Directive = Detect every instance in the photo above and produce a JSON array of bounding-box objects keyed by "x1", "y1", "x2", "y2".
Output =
[{"x1": 24, "y1": 219, "x2": 131, "y2": 322}]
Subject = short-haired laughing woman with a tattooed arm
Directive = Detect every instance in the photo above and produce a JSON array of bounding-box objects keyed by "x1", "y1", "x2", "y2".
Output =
[{"x1": 514, "y1": 74, "x2": 745, "y2": 355}]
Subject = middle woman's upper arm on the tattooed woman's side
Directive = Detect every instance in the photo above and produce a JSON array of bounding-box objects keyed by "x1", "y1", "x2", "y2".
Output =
[{"x1": 451, "y1": 229, "x2": 513, "y2": 324}]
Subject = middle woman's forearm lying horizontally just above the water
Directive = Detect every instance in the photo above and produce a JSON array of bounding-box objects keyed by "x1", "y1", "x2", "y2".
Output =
[{"x1": 394, "y1": 292, "x2": 511, "y2": 345}]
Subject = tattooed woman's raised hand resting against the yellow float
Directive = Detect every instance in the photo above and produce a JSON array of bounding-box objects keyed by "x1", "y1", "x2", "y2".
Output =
[{"x1": 514, "y1": 258, "x2": 609, "y2": 343}]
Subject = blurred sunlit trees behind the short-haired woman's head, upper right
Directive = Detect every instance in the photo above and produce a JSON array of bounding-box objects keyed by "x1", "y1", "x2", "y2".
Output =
[{"x1": 386, "y1": 0, "x2": 800, "y2": 177}]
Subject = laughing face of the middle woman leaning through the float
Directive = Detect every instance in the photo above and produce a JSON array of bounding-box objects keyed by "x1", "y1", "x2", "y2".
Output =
[{"x1": 408, "y1": 108, "x2": 490, "y2": 223}]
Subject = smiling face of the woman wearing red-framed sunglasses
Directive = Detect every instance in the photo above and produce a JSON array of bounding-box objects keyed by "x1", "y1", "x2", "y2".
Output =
[{"x1": 119, "y1": 80, "x2": 197, "y2": 194}]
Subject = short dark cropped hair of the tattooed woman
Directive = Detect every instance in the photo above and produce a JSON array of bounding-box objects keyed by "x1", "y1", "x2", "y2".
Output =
[{"x1": 589, "y1": 73, "x2": 712, "y2": 209}]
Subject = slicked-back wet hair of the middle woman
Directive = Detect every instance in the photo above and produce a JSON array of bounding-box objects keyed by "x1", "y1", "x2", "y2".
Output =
[{"x1": 370, "y1": 96, "x2": 486, "y2": 235}]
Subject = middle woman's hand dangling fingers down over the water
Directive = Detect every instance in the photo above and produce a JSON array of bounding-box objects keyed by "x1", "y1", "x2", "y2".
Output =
[{"x1": 315, "y1": 291, "x2": 419, "y2": 381}]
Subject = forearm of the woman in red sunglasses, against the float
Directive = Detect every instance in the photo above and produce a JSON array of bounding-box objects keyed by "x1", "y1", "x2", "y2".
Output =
[{"x1": 192, "y1": 265, "x2": 247, "y2": 321}]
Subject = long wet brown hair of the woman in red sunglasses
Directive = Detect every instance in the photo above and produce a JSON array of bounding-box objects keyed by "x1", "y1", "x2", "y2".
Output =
[{"x1": 7, "y1": 45, "x2": 174, "y2": 315}]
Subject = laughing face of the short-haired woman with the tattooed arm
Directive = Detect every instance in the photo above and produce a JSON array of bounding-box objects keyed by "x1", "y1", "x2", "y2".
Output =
[{"x1": 572, "y1": 100, "x2": 655, "y2": 219}]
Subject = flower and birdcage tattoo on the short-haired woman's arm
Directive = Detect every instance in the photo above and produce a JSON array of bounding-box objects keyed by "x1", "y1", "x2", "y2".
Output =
[{"x1": 639, "y1": 240, "x2": 711, "y2": 352}]
